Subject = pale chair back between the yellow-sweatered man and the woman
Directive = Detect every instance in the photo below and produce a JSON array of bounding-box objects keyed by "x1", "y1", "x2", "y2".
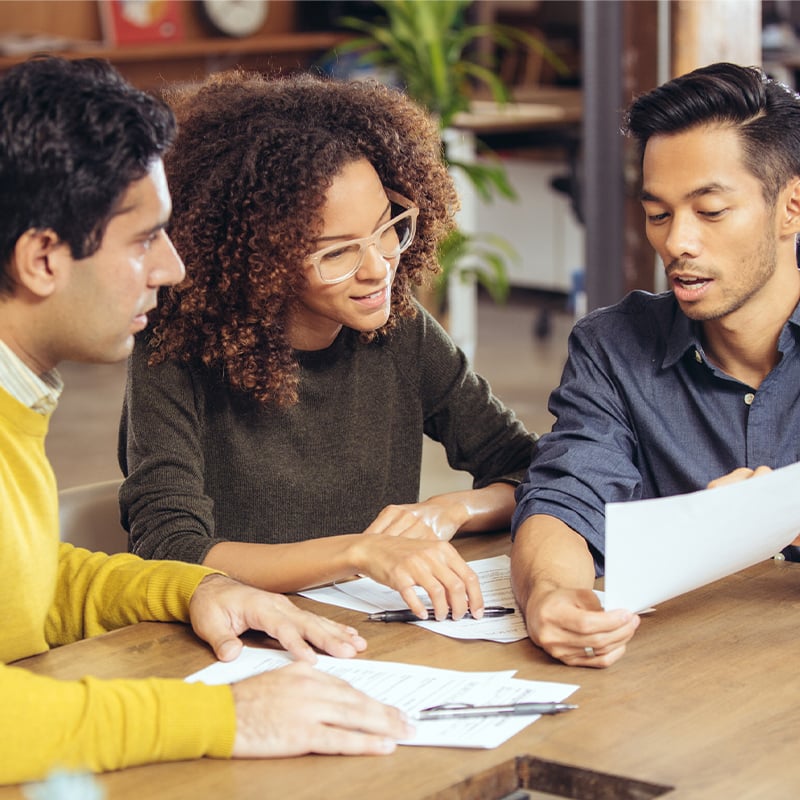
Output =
[{"x1": 58, "y1": 478, "x2": 128, "y2": 553}]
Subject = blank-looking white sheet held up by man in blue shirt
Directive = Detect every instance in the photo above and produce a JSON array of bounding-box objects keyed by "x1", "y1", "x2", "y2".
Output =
[{"x1": 604, "y1": 456, "x2": 800, "y2": 611}]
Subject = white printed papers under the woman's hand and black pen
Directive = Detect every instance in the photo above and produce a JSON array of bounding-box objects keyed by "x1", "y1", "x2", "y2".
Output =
[{"x1": 299, "y1": 556, "x2": 528, "y2": 642}]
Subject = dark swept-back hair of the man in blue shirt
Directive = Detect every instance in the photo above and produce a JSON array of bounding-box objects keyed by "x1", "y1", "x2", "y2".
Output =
[{"x1": 623, "y1": 62, "x2": 800, "y2": 204}]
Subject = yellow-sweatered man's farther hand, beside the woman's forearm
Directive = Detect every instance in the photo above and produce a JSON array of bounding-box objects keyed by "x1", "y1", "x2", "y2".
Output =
[{"x1": 189, "y1": 574, "x2": 367, "y2": 664}]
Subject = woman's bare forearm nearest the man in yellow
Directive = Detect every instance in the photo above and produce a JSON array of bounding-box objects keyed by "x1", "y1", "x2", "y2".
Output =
[{"x1": 203, "y1": 534, "x2": 364, "y2": 593}]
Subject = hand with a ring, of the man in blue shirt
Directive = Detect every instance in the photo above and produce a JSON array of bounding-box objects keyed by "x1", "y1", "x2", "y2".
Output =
[{"x1": 525, "y1": 588, "x2": 640, "y2": 667}]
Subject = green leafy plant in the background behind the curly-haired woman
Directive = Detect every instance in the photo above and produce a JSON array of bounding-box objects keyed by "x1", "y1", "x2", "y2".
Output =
[{"x1": 337, "y1": 0, "x2": 565, "y2": 310}]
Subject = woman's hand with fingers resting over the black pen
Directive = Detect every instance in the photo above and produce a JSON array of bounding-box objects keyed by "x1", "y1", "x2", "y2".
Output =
[{"x1": 349, "y1": 535, "x2": 483, "y2": 619}]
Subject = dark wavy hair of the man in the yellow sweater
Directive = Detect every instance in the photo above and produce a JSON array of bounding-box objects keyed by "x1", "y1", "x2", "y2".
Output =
[{"x1": 0, "y1": 56, "x2": 176, "y2": 292}]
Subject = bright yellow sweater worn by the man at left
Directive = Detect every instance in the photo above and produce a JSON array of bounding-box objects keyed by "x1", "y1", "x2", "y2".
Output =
[{"x1": 0, "y1": 388, "x2": 236, "y2": 783}]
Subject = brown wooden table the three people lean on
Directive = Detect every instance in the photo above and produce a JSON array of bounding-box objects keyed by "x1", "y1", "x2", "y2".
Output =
[{"x1": 0, "y1": 536, "x2": 800, "y2": 800}]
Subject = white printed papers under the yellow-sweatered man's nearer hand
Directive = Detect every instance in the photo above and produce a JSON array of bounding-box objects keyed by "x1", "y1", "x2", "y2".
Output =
[{"x1": 186, "y1": 647, "x2": 580, "y2": 749}]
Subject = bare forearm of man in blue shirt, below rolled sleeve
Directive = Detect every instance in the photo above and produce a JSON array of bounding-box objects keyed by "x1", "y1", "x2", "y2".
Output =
[{"x1": 511, "y1": 514, "x2": 595, "y2": 608}]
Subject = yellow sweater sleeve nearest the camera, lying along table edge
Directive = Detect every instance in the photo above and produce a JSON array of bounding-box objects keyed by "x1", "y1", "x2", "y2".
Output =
[{"x1": 0, "y1": 666, "x2": 236, "y2": 783}]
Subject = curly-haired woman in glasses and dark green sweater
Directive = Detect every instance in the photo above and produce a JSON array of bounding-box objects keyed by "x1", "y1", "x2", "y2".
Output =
[{"x1": 120, "y1": 72, "x2": 536, "y2": 618}]
